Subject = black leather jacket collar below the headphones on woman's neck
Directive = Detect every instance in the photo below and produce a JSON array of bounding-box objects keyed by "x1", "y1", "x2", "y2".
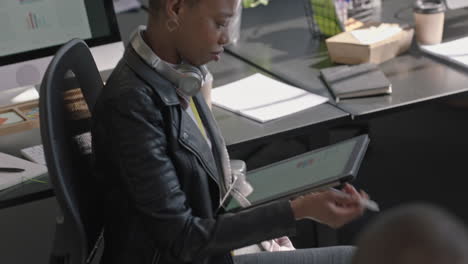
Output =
[{"x1": 123, "y1": 45, "x2": 180, "y2": 105}]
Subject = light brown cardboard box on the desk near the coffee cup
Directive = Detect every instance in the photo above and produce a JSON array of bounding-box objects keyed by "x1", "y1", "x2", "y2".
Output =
[{"x1": 325, "y1": 24, "x2": 414, "y2": 64}]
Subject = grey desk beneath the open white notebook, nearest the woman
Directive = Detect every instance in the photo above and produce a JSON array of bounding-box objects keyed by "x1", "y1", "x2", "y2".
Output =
[{"x1": 0, "y1": 54, "x2": 349, "y2": 208}]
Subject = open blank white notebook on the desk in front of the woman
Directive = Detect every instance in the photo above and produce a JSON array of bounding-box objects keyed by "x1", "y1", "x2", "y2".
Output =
[{"x1": 212, "y1": 73, "x2": 328, "y2": 122}]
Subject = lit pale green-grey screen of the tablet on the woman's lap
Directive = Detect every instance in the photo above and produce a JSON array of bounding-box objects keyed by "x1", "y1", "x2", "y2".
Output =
[{"x1": 226, "y1": 136, "x2": 368, "y2": 210}]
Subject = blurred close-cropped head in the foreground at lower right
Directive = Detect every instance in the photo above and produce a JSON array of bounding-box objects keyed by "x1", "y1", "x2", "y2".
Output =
[{"x1": 353, "y1": 204, "x2": 468, "y2": 264}]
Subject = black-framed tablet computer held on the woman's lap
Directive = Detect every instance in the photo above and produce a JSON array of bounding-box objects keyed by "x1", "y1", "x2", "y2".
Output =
[{"x1": 225, "y1": 135, "x2": 369, "y2": 212}]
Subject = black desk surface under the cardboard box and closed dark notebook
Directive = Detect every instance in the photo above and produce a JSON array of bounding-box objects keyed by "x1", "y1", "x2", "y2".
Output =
[{"x1": 229, "y1": 0, "x2": 468, "y2": 117}]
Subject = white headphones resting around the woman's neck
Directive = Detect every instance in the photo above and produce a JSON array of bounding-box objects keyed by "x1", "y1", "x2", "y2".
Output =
[{"x1": 130, "y1": 26, "x2": 208, "y2": 96}]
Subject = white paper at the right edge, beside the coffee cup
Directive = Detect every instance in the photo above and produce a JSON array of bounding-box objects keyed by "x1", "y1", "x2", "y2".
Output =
[{"x1": 419, "y1": 37, "x2": 468, "y2": 68}]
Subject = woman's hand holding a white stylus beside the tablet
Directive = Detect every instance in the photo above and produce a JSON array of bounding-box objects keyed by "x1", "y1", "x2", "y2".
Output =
[{"x1": 291, "y1": 184, "x2": 369, "y2": 228}]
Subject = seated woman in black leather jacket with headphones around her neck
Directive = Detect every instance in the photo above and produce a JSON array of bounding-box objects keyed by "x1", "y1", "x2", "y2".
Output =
[{"x1": 92, "y1": 0, "x2": 365, "y2": 264}]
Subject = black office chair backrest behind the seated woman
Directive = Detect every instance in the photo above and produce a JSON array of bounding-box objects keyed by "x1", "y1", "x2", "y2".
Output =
[{"x1": 39, "y1": 39, "x2": 103, "y2": 264}]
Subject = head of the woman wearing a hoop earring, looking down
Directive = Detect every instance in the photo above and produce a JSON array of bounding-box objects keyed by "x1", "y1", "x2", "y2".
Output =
[{"x1": 148, "y1": 0, "x2": 240, "y2": 65}]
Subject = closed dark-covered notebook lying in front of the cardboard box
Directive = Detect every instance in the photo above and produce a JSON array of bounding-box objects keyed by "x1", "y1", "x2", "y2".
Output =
[{"x1": 320, "y1": 63, "x2": 392, "y2": 102}]
